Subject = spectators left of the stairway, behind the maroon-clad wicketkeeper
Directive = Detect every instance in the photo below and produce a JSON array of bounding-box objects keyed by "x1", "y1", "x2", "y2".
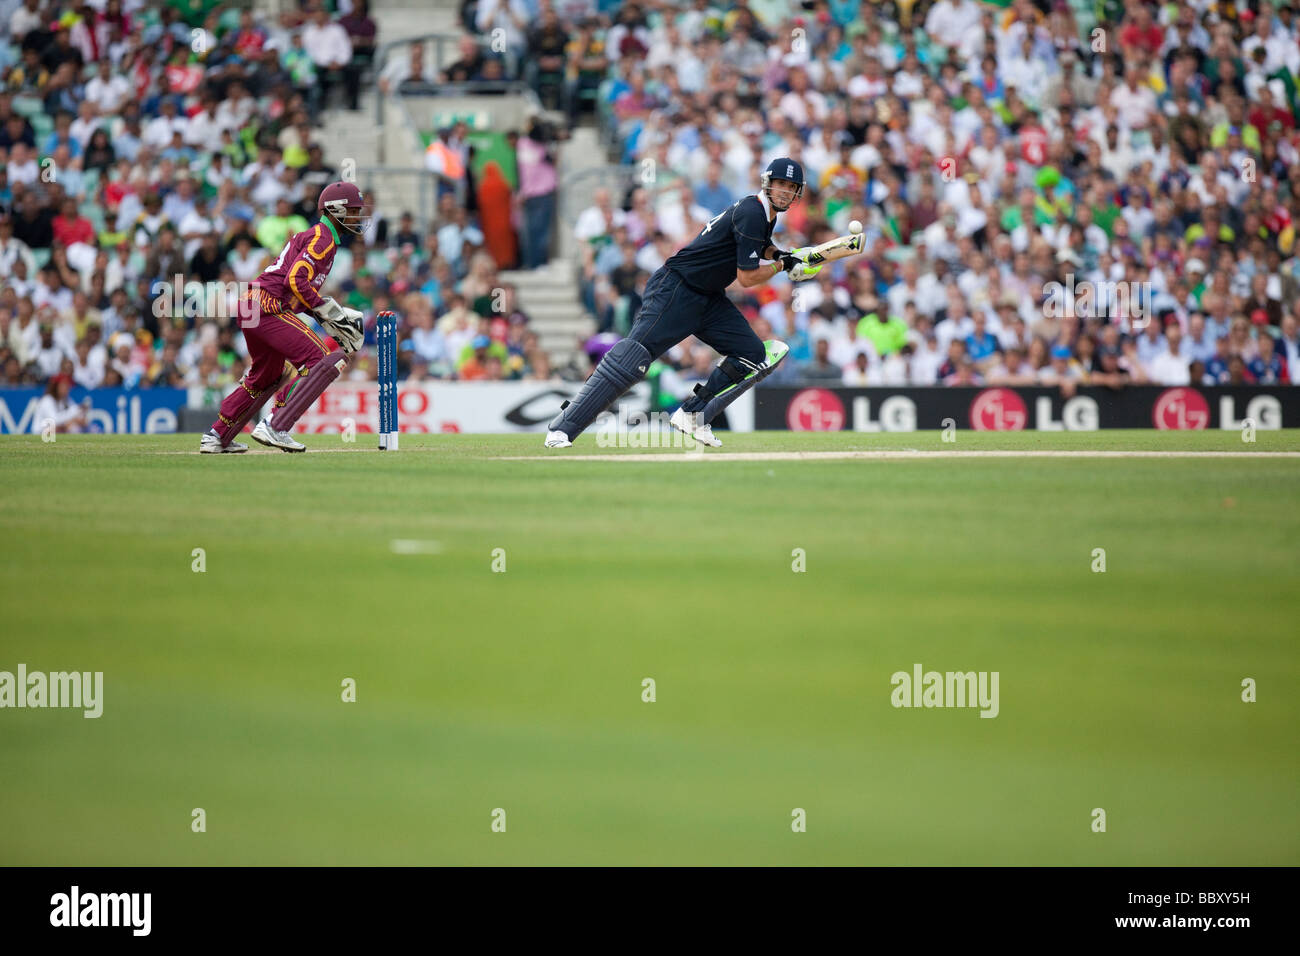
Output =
[{"x1": 0, "y1": 0, "x2": 550, "y2": 427}]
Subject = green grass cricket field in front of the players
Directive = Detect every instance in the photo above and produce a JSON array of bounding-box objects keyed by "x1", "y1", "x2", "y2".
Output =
[{"x1": 0, "y1": 431, "x2": 1300, "y2": 865}]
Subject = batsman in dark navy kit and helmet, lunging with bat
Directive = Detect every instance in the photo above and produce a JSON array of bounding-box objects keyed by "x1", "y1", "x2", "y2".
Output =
[{"x1": 546, "y1": 159, "x2": 822, "y2": 449}]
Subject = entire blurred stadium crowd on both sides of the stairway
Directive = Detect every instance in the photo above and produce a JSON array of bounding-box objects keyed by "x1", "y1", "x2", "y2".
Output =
[{"x1": 0, "y1": 0, "x2": 1300, "y2": 429}]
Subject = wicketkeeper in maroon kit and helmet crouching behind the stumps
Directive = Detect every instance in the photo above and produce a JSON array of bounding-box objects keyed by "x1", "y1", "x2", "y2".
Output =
[{"x1": 199, "y1": 182, "x2": 371, "y2": 454}]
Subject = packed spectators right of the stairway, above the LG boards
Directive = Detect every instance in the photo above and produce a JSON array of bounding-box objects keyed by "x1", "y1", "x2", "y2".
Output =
[{"x1": 540, "y1": 0, "x2": 1300, "y2": 389}]
